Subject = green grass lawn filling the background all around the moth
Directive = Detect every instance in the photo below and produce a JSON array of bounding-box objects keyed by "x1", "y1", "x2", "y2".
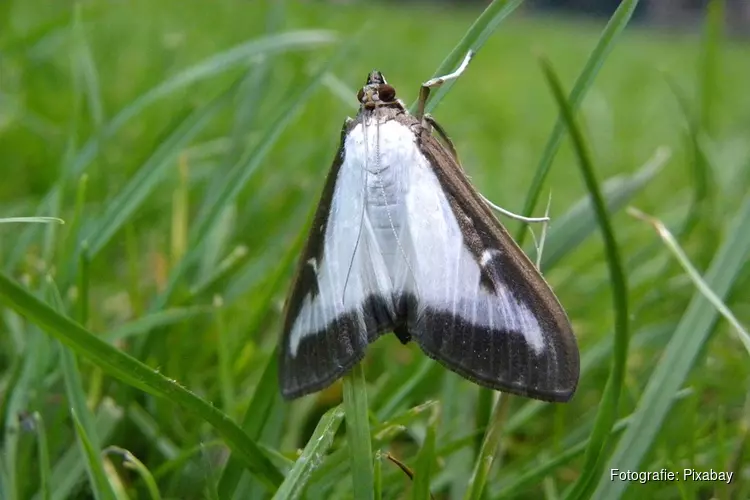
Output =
[{"x1": 0, "y1": 0, "x2": 750, "y2": 500}]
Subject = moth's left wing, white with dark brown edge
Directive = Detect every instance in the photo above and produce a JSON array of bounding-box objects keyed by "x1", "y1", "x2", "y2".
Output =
[{"x1": 279, "y1": 125, "x2": 395, "y2": 399}]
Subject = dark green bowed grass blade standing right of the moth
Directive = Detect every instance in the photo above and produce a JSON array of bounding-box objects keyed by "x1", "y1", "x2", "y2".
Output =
[{"x1": 542, "y1": 54, "x2": 629, "y2": 498}]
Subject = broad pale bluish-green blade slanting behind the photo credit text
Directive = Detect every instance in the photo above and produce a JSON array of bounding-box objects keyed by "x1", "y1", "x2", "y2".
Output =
[{"x1": 594, "y1": 198, "x2": 750, "y2": 499}]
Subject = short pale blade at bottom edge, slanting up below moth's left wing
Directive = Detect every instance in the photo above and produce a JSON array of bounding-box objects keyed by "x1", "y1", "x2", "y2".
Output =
[{"x1": 273, "y1": 406, "x2": 344, "y2": 500}]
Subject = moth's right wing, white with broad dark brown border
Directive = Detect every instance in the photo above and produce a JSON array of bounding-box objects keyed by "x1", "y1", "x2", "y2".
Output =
[{"x1": 406, "y1": 134, "x2": 579, "y2": 401}]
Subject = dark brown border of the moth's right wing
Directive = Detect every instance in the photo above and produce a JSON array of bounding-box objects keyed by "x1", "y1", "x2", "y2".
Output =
[{"x1": 409, "y1": 126, "x2": 580, "y2": 402}]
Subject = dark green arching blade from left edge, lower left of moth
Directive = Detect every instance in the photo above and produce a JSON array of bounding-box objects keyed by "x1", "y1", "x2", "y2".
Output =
[{"x1": 0, "y1": 273, "x2": 282, "y2": 489}]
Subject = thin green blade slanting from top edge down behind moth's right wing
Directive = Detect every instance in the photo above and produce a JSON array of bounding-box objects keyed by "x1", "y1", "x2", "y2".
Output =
[{"x1": 516, "y1": 0, "x2": 638, "y2": 245}]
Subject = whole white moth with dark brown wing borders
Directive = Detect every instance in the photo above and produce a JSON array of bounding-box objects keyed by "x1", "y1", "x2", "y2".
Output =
[{"x1": 279, "y1": 53, "x2": 579, "y2": 402}]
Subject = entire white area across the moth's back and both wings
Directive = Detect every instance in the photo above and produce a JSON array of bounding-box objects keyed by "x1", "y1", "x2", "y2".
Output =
[{"x1": 289, "y1": 120, "x2": 545, "y2": 357}]
